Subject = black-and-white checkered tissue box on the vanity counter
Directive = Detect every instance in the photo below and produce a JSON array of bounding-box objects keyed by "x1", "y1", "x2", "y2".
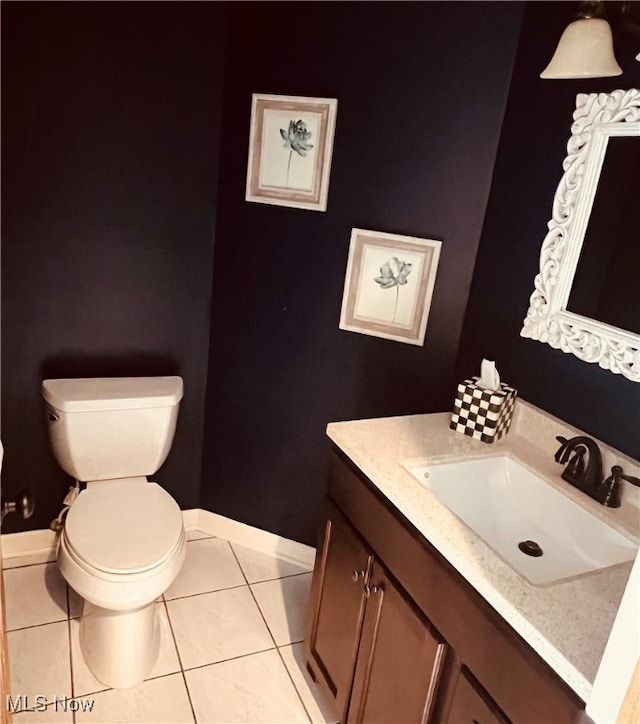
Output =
[{"x1": 449, "y1": 377, "x2": 518, "y2": 442}]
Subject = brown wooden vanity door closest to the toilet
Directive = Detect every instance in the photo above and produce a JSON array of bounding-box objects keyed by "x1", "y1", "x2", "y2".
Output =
[{"x1": 305, "y1": 502, "x2": 373, "y2": 721}]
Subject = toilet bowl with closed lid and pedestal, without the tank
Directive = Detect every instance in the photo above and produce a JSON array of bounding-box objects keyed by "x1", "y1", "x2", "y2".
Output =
[{"x1": 58, "y1": 479, "x2": 185, "y2": 688}]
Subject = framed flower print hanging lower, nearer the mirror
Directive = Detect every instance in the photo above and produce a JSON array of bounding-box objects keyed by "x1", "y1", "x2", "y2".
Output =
[{"x1": 340, "y1": 229, "x2": 441, "y2": 345}]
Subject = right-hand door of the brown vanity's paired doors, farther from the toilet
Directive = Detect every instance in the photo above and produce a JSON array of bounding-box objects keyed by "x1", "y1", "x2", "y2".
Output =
[{"x1": 347, "y1": 562, "x2": 446, "y2": 724}]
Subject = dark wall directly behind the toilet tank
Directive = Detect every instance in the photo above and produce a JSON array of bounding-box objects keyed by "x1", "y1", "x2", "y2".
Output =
[{"x1": 2, "y1": 2, "x2": 224, "y2": 532}]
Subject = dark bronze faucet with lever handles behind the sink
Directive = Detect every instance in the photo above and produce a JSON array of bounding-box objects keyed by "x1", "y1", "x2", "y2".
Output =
[{"x1": 555, "y1": 435, "x2": 640, "y2": 508}]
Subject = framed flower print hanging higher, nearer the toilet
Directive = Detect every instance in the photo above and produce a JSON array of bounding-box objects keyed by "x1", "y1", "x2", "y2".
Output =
[{"x1": 245, "y1": 93, "x2": 337, "y2": 211}]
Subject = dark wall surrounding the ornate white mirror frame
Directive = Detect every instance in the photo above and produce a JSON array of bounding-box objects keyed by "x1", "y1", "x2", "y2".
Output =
[{"x1": 457, "y1": 2, "x2": 640, "y2": 458}]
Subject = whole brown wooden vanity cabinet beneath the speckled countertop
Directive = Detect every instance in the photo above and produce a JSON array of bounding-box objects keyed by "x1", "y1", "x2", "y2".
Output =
[{"x1": 305, "y1": 449, "x2": 584, "y2": 724}]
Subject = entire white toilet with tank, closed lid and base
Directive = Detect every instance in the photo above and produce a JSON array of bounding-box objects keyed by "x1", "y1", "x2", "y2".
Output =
[{"x1": 42, "y1": 377, "x2": 185, "y2": 688}]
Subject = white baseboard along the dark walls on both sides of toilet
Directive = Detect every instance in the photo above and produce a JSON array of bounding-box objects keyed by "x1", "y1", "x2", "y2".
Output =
[{"x1": 2, "y1": 508, "x2": 315, "y2": 567}]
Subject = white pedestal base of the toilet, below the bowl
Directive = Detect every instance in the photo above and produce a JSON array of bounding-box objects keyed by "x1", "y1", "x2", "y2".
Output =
[{"x1": 80, "y1": 599, "x2": 160, "y2": 689}]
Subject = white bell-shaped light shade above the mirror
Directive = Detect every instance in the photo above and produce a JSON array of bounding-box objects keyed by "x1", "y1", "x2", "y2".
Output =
[{"x1": 540, "y1": 18, "x2": 622, "y2": 78}]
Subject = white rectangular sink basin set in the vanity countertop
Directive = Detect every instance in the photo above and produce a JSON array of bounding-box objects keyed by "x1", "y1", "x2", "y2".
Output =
[{"x1": 405, "y1": 457, "x2": 638, "y2": 585}]
